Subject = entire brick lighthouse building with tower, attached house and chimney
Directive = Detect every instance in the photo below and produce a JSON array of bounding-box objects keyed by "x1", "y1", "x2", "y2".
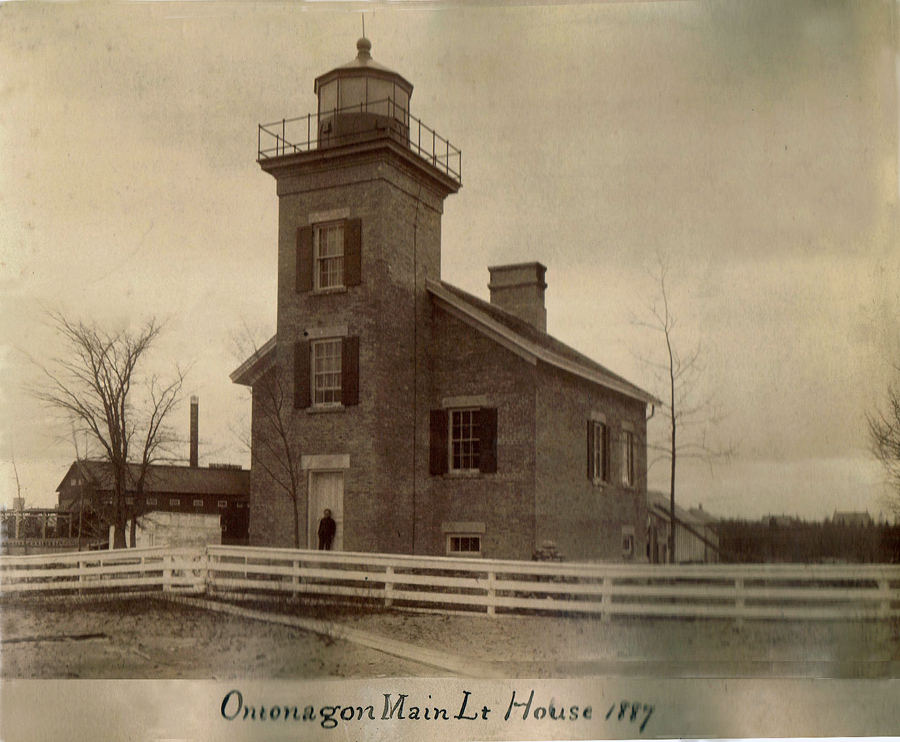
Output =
[{"x1": 231, "y1": 39, "x2": 655, "y2": 560}]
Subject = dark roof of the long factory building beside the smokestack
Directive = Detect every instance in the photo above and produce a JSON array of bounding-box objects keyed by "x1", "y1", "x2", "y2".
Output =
[{"x1": 56, "y1": 460, "x2": 250, "y2": 496}]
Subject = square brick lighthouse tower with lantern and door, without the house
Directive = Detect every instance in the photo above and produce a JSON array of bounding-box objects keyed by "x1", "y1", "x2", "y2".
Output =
[{"x1": 246, "y1": 38, "x2": 461, "y2": 553}]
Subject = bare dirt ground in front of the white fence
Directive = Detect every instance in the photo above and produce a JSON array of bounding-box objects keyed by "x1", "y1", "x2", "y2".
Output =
[{"x1": 0, "y1": 598, "x2": 900, "y2": 680}]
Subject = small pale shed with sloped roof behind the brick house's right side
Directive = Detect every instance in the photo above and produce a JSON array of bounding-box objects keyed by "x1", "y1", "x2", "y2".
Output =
[{"x1": 647, "y1": 491, "x2": 719, "y2": 564}]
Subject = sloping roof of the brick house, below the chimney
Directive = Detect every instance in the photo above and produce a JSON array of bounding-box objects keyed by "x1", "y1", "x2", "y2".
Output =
[{"x1": 426, "y1": 280, "x2": 661, "y2": 405}]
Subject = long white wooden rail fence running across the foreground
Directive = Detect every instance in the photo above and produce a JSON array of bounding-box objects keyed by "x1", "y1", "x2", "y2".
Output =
[{"x1": 0, "y1": 546, "x2": 900, "y2": 620}]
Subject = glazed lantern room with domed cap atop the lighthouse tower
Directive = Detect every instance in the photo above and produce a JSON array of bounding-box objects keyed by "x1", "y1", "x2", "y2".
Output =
[{"x1": 315, "y1": 38, "x2": 413, "y2": 148}]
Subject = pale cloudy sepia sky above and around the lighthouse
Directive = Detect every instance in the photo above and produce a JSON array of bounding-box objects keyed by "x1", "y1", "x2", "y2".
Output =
[{"x1": 0, "y1": 0, "x2": 900, "y2": 519}]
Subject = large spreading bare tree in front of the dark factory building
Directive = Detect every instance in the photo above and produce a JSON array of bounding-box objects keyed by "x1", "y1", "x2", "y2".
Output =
[{"x1": 32, "y1": 312, "x2": 185, "y2": 549}]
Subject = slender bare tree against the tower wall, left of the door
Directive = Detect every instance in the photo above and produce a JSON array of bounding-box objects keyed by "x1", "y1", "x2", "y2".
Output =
[{"x1": 234, "y1": 326, "x2": 304, "y2": 549}]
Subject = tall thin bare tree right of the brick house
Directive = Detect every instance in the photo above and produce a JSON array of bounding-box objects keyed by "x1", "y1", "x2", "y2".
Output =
[{"x1": 635, "y1": 254, "x2": 735, "y2": 562}]
